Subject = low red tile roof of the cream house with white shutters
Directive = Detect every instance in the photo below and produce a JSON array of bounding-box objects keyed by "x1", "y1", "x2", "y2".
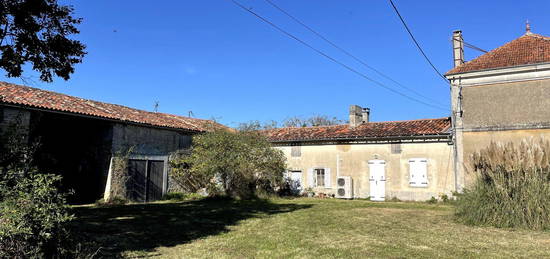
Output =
[{"x1": 263, "y1": 118, "x2": 451, "y2": 142}]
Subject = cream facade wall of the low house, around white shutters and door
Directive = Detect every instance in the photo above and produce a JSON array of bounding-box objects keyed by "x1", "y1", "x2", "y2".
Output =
[{"x1": 277, "y1": 143, "x2": 455, "y2": 201}]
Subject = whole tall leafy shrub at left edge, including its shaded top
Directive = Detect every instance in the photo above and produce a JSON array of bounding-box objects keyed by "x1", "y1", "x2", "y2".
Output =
[{"x1": 0, "y1": 120, "x2": 75, "y2": 258}]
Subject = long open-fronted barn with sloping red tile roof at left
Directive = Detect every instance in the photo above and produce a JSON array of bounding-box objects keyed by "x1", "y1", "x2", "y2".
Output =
[{"x1": 0, "y1": 82, "x2": 224, "y2": 204}]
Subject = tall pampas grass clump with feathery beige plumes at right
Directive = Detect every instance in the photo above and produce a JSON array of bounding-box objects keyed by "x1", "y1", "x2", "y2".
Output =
[{"x1": 456, "y1": 139, "x2": 550, "y2": 230}]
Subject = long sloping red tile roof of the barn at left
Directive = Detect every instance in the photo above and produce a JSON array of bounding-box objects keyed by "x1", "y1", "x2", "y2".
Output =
[{"x1": 0, "y1": 82, "x2": 225, "y2": 131}]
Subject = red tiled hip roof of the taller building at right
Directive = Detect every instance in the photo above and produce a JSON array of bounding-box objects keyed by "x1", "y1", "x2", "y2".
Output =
[{"x1": 446, "y1": 33, "x2": 550, "y2": 75}]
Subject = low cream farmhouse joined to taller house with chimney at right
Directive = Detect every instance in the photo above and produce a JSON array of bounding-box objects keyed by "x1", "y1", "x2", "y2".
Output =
[{"x1": 265, "y1": 27, "x2": 550, "y2": 200}]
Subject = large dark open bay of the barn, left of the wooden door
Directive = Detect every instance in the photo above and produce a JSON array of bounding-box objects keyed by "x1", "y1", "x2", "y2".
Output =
[{"x1": 31, "y1": 112, "x2": 112, "y2": 204}]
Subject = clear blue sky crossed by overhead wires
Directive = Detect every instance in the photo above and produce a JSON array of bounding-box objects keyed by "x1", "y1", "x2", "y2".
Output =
[{"x1": 1, "y1": 0, "x2": 550, "y2": 126}]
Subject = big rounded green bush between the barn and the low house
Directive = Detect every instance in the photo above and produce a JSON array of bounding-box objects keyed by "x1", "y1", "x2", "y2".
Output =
[{"x1": 171, "y1": 130, "x2": 286, "y2": 198}]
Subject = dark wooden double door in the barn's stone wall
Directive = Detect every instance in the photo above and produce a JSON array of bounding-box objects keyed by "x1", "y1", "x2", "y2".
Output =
[{"x1": 126, "y1": 159, "x2": 164, "y2": 202}]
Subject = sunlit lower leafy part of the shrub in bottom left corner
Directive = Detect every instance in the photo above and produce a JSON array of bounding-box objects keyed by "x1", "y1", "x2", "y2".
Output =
[{"x1": 0, "y1": 174, "x2": 73, "y2": 258}]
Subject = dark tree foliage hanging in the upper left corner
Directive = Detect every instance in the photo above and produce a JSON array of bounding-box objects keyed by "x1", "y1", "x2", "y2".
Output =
[{"x1": 0, "y1": 0, "x2": 86, "y2": 82}]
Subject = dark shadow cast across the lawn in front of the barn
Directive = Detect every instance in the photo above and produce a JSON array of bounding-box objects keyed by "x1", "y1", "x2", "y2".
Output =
[{"x1": 72, "y1": 199, "x2": 312, "y2": 257}]
